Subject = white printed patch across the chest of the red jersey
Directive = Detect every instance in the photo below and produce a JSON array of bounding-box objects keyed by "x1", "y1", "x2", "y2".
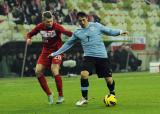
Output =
[{"x1": 40, "y1": 30, "x2": 56, "y2": 38}]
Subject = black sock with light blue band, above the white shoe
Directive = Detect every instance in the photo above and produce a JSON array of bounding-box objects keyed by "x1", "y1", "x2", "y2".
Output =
[{"x1": 81, "y1": 78, "x2": 89, "y2": 99}]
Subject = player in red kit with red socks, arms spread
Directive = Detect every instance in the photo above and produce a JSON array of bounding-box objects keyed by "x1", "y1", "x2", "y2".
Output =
[{"x1": 26, "y1": 11, "x2": 72, "y2": 104}]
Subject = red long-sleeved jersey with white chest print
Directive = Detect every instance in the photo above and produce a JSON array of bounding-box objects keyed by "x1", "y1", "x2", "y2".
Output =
[{"x1": 27, "y1": 22, "x2": 72, "y2": 51}]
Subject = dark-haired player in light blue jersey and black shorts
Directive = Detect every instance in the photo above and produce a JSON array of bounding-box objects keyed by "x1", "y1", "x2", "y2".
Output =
[{"x1": 49, "y1": 12, "x2": 128, "y2": 106}]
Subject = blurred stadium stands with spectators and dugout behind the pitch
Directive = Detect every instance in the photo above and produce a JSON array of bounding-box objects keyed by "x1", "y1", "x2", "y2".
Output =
[{"x1": 0, "y1": 0, "x2": 160, "y2": 77}]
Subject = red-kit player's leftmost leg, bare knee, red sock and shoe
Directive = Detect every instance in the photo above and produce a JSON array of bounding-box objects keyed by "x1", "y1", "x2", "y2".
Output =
[{"x1": 35, "y1": 64, "x2": 53, "y2": 104}]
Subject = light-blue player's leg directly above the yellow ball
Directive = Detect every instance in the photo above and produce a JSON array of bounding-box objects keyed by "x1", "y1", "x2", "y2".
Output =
[{"x1": 96, "y1": 58, "x2": 115, "y2": 95}]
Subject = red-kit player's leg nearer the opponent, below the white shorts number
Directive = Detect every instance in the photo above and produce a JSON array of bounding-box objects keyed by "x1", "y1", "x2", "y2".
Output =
[{"x1": 51, "y1": 55, "x2": 64, "y2": 104}]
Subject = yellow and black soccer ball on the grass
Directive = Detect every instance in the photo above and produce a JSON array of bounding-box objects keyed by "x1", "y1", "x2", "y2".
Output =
[{"x1": 104, "y1": 94, "x2": 117, "y2": 106}]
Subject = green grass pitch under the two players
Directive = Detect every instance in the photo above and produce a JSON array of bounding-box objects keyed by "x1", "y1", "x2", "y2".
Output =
[{"x1": 0, "y1": 72, "x2": 160, "y2": 114}]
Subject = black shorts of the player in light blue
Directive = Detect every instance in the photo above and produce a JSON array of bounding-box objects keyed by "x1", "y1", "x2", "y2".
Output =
[{"x1": 82, "y1": 56, "x2": 112, "y2": 78}]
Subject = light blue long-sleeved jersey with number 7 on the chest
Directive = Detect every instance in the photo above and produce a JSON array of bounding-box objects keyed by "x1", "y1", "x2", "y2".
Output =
[{"x1": 52, "y1": 22, "x2": 121, "y2": 58}]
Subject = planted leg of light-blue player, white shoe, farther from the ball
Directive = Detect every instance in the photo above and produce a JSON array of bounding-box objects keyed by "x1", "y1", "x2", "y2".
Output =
[{"x1": 76, "y1": 57, "x2": 94, "y2": 106}]
